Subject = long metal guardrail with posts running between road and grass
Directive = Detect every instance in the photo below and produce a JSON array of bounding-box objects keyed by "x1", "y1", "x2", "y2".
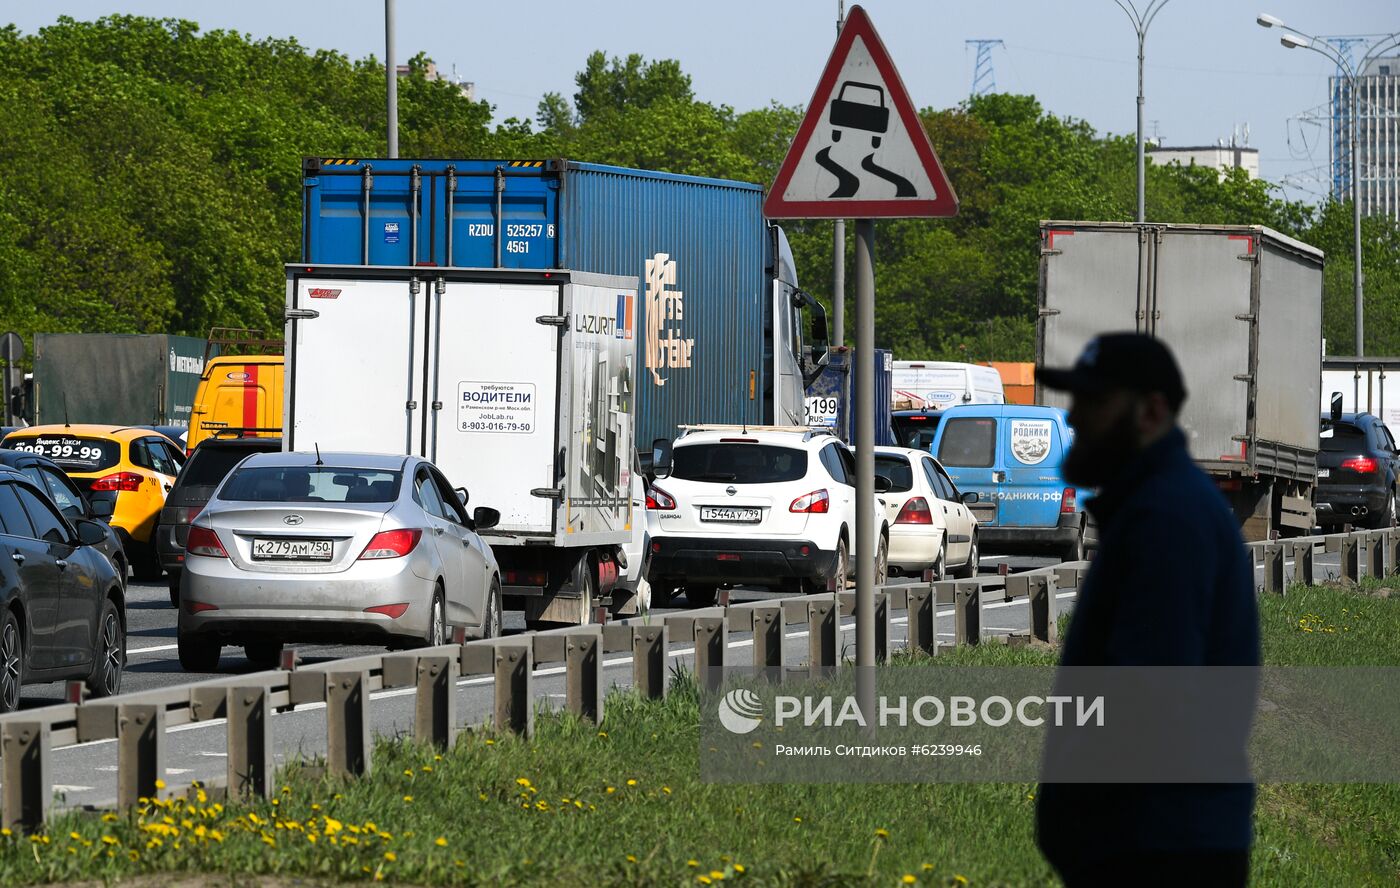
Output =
[{"x1": 0, "y1": 529, "x2": 1400, "y2": 829}]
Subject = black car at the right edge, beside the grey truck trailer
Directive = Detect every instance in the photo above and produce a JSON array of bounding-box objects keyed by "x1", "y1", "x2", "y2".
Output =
[{"x1": 1313, "y1": 413, "x2": 1400, "y2": 528}]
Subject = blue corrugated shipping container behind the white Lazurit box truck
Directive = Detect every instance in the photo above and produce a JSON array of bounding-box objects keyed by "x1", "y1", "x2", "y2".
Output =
[{"x1": 301, "y1": 158, "x2": 776, "y2": 451}]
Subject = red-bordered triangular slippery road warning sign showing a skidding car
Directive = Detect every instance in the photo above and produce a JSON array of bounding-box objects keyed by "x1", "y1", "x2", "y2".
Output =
[{"x1": 763, "y1": 6, "x2": 958, "y2": 218}]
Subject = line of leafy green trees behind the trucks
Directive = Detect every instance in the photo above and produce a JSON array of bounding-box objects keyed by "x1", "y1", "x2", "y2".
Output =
[{"x1": 0, "y1": 17, "x2": 1400, "y2": 361}]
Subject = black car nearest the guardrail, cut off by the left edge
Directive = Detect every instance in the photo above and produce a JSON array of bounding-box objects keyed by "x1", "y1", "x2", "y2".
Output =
[{"x1": 0, "y1": 472, "x2": 126, "y2": 712}]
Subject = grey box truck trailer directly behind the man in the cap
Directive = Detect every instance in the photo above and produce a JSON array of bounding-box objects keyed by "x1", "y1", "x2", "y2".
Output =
[{"x1": 1036, "y1": 221, "x2": 1323, "y2": 541}]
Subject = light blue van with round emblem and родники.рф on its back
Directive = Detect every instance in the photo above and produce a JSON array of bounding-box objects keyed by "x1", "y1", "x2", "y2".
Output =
[{"x1": 930, "y1": 403, "x2": 1092, "y2": 562}]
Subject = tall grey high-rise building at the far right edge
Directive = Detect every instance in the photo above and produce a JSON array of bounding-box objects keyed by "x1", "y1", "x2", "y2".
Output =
[{"x1": 1330, "y1": 56, "x2": 1400, "y2": 221}]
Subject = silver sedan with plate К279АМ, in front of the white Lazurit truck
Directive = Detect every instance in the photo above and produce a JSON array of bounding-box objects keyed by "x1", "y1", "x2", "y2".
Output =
[{"x1": 179, "y1": 452, "x2": 501, "y2": 672}]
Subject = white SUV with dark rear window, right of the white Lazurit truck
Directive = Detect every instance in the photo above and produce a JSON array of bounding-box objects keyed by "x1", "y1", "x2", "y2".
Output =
[{"x1": 647, "y1": 426, "x2": 889, "y2": 606}]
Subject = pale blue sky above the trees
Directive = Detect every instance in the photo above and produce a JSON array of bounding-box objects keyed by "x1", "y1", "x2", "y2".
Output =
[{"x1": 0, "y1": 0, "x2": 1400, "y2": 200}]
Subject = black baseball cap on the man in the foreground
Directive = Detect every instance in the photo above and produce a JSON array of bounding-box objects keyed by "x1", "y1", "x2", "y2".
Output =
[{"x1": 1036, "y1": 333, "x2": 1186, "y2": 410}]
